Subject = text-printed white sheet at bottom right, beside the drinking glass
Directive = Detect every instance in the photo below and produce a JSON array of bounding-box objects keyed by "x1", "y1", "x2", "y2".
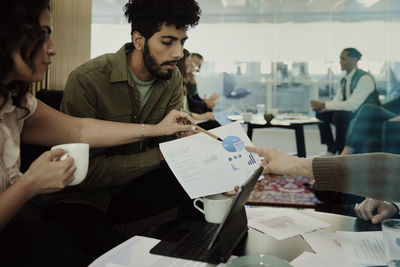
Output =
[{"x1": 336, "y1": 231, "x2": 386, "y2": 265}]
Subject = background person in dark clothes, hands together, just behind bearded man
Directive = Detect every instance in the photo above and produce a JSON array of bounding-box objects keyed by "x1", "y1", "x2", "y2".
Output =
[{"x1": 186, "y1": 53, "x2": 219, "y2": 114}]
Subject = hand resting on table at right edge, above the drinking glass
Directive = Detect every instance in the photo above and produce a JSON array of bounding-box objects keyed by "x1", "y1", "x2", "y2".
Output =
[{"x1": 354, "y1": 198, "x2": 397, "y2": 224}]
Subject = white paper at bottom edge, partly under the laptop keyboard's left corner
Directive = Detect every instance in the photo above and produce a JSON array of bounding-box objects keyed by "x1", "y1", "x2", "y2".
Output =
[{"x1": 89, "y1": 236, "x2": 225, "y2": 267}]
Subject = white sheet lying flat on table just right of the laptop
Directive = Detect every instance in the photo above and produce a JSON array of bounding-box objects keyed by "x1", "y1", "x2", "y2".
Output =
[{"x1": 246, "y1": 208, "x2": 330, "y2": 240}]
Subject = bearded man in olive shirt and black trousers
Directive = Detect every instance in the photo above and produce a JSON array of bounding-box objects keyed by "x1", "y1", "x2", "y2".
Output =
[{"x1": 45, "y1": 0, "x2": 202, "y2": 258}]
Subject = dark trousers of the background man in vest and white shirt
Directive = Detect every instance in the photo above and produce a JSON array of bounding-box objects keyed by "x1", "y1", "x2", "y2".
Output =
[{"x1": 316, "y1": 110, "x2": 354, "y2": 154}]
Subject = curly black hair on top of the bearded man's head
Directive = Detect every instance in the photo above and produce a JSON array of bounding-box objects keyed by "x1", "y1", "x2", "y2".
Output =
[{"x1": 124, "y1": 0, "x2": 201, "y2": 40}]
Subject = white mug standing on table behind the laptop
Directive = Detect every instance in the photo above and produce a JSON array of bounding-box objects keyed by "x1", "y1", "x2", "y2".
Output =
[{"x1": 193, "y1": 194, "x2": 232, "y2": 223}]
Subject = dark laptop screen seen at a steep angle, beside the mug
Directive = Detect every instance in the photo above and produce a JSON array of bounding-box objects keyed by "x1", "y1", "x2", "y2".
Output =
[{"x1": 208, "y1": 167, "x2": 263, "y2": 250}]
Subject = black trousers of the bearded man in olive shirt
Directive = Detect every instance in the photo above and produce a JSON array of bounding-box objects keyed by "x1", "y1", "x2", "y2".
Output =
[{"x1": 45, "y1": 165, "x2": 196, "y2": 260}]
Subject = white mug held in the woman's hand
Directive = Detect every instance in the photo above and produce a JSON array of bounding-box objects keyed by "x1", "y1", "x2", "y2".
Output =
[{"x1": 51, "y1": 143, "x2": 89, "y2": 185}]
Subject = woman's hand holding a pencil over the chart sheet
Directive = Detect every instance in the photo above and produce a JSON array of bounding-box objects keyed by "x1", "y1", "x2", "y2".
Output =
[{"x1": 155, "y1": 110, "x2": 196, "y2": 136}]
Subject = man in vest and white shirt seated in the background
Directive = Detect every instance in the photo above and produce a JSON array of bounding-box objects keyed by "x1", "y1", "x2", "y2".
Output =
[{"x1": 310, "y1": 48, "x2": 380, "y2": 156}]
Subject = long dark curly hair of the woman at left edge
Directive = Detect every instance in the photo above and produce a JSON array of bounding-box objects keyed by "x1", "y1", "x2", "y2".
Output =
[{"x1": 0, "y1": 0, "x2": 50, "y2": 112}]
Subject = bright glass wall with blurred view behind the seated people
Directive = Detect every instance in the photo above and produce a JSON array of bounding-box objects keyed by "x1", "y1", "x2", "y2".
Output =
[{"x1": 92, "y1": 0, "x2": 400, "y2": 120}]
